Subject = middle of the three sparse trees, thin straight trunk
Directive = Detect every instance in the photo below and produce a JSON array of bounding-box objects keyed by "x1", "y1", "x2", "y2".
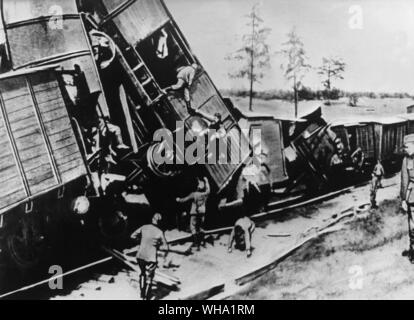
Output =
[{"x1": 278, "y1": 28, "x2": 311, "y2": 117}]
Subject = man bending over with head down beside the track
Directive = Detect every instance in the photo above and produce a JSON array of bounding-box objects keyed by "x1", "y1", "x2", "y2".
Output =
[{"x1": 228, "y1": 215, "x2": 256, "y2": 258}]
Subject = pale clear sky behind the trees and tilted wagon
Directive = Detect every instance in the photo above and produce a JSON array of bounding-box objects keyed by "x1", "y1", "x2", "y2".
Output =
[{"x1": 165, "y1": 0, "x2": 414, "y2": 94}]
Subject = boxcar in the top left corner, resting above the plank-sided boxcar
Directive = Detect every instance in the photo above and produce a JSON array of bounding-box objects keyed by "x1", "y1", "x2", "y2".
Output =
[{"x1": 2, "y1": 0, "x2": 109, "y2": 119}]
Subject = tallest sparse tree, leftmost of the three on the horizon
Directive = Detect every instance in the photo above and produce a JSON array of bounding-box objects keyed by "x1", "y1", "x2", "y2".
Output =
[{"x1": 226, "y1": 4, "x2": 271, "y2": 111}]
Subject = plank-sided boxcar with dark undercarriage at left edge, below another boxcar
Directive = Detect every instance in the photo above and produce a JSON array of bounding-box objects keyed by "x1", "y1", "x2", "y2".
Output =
[{"x1": 0, "y1": 67, "x2": 88, "y2": 268}]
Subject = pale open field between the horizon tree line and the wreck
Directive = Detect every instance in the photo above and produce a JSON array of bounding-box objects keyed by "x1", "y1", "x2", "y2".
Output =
[{"x1": 231, "y1": 97, "x2": 414, "y2": 122}]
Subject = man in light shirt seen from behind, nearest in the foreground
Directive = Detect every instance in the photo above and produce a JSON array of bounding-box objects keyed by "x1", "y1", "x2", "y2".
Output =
[{"x1": 131, "y1": 213, "x2": 169, "y2": 300}]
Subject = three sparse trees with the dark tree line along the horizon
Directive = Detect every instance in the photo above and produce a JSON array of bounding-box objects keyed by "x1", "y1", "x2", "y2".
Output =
[{"x1": 223, "y1": 4, "x2": 413, "y2": 112}]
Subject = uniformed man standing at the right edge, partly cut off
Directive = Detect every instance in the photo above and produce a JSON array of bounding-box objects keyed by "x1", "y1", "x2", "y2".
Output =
[{"x1": 400, "y1": 134, "x2": 414, "y2": 264}]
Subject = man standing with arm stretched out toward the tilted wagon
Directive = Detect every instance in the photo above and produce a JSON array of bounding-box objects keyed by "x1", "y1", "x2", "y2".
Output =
[{"x1": 176, "y1": 177, "x2": 210, "y2": 251}]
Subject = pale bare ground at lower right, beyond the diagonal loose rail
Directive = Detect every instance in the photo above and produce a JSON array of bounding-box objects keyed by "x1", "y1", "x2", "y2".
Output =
[{"x1": 229, "y1": 186, "x2": 414, "y2": 300}]
